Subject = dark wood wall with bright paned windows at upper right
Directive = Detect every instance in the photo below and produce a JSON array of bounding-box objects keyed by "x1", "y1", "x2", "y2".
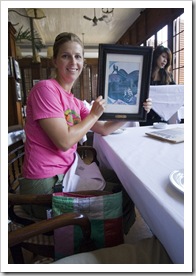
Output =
[{"x1": 117, "y1": 8, "x2": 184, "y2": 84}]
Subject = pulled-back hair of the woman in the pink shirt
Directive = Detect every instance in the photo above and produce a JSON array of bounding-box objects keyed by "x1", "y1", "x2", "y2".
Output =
[{"x1": 53, "y1": 32, "x2": 83, "y2": 58}]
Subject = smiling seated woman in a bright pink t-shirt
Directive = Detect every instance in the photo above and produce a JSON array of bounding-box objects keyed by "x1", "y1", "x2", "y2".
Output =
[{"x1": 20, "y1": 33, "x2": 151, "y2": 235}]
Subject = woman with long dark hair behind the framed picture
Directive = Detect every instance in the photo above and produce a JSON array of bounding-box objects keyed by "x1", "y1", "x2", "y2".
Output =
[{"x1": 140, "y1": 45, "x2": 175, "y2": 126}]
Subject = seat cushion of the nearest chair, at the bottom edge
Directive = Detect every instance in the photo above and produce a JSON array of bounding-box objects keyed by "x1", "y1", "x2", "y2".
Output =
[{"x1": 53, "y1": 236, "x2": 172, "y2": 264}]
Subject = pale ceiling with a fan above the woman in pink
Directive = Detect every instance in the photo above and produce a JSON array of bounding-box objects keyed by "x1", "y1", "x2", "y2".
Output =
[{"x1": 8, "y1": 8, "x2": 143, "y2": 56}]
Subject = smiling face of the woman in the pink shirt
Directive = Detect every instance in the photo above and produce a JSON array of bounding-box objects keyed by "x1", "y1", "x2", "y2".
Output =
[{"x1": 54, "y1": 41, "x2": 84, "y2": 83}]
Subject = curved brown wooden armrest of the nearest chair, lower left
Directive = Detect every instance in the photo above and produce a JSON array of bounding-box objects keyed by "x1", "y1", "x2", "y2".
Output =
[{"x1": 8, "y1": 205, "x2": 93, "y2": 264}]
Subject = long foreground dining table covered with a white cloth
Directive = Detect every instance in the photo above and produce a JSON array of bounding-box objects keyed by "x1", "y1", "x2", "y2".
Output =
[{"x1": 93, "y1": 124, "x2": 184, "y2": 264}]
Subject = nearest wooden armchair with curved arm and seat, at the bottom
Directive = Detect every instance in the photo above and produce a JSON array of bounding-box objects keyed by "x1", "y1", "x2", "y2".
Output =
[{"x1": 8, "y1": 207, "x2": 172, "y2": 266}]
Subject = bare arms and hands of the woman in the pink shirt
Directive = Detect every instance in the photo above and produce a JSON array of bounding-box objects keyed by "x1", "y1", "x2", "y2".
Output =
[{"x1": 39, "y1": 96, "x2": 152, "y2": 151}]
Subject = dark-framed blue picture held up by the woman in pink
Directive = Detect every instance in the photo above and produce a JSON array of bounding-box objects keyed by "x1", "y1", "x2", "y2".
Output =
[{"x1": 98, "y1": 44, "x2": 153, "y2": 121}]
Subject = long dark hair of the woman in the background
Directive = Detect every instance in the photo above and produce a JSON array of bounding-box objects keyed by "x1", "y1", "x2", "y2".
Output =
[{"x1": 152, "y1": 45, "x2": 172, "y2": 84}]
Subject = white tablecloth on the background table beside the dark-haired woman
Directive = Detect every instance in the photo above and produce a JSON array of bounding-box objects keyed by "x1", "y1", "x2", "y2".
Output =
[{"x1": 149, "y1": 85, "x2": 184, "y2": 121}]
